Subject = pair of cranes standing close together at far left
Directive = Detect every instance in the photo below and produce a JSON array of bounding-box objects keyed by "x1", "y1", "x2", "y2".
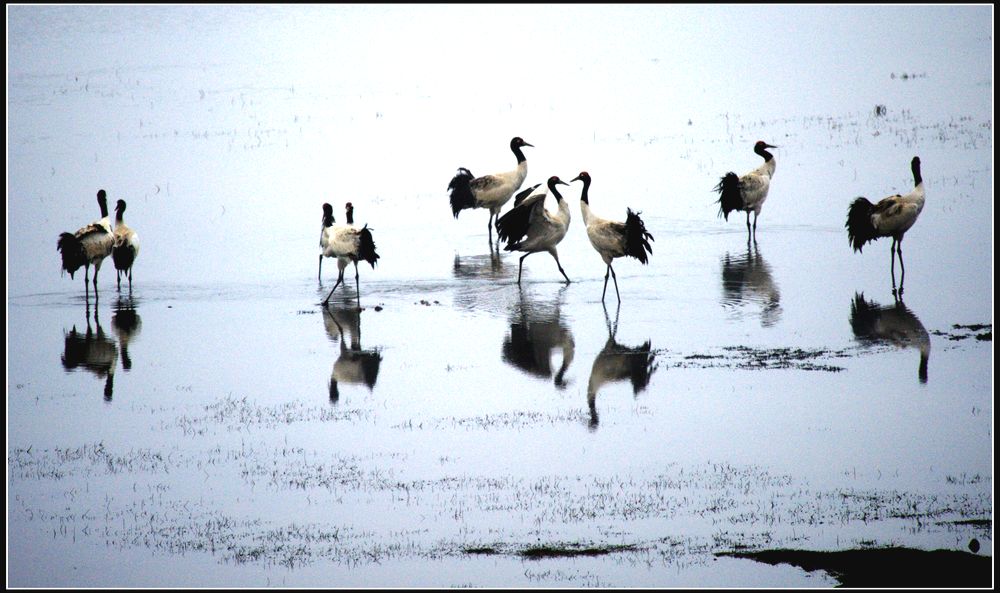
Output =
[{"x1": 56, "y1": 189, "x2": 139, "y2": 299}]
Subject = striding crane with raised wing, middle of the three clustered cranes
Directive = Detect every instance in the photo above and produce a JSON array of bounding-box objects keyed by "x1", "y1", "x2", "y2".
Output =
[{"x1": 497, "y1": 175, "x2": 570, "y2": 284}]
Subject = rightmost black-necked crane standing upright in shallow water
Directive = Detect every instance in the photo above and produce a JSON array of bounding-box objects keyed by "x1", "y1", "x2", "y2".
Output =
[{"x1": 844, "y1": 156, "x2": 924, "y2": 294}]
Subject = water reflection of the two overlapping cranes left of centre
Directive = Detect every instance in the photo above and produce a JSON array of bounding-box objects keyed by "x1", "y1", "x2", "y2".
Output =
[{"x1": 323, "y1": 300, "x2": 382, "y2": 403}]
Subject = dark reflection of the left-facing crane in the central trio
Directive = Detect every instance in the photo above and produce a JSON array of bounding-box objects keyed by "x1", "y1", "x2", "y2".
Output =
[{"x1": 587, "y1": 304, "x2": 657, "y2": 430}]
